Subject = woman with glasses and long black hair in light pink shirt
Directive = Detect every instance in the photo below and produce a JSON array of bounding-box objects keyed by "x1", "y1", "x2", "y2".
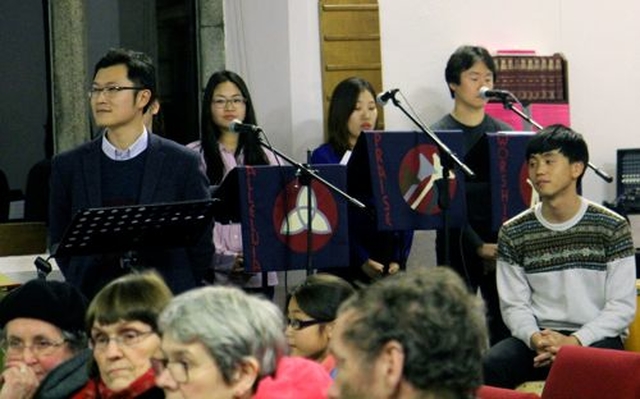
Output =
[{"x1": 188, "y1": 71, "x2": 278, "y2": 298}]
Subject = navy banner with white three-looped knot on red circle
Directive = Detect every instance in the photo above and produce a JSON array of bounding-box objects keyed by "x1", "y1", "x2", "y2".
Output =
[{"x1": 214, "y1": 165, "x2": 349, "y2": 273}]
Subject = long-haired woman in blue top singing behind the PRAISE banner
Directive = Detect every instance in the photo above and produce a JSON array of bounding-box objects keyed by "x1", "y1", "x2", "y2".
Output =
[{"x1": 311, "y1": 77, "x2": 413, "y2": 284}]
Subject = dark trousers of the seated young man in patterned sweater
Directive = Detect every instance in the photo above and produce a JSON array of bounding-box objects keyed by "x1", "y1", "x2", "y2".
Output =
[{"x1": 483, "y1": 337, "x2": 623, "y2": 389}]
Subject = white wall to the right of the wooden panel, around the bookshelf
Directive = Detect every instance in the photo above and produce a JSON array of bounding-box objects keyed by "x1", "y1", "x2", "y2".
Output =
[{"x1": 380, "y1": 0, "x2": 640, "y2": 206}]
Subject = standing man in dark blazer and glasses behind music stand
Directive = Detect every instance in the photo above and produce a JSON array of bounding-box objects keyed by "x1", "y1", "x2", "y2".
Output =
[{"x1": 49, "y1": 49, "x2": 213, "y2": 298}]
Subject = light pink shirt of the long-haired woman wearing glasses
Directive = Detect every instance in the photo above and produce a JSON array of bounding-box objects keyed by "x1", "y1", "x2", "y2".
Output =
[{"x1": 187, "y1": 141, "x2": 278, "y2": 288}]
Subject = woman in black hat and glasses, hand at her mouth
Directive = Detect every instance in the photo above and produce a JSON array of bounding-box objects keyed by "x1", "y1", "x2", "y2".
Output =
[{"x1": 0, "y1": 280, "x2": 88, "y2": 398}]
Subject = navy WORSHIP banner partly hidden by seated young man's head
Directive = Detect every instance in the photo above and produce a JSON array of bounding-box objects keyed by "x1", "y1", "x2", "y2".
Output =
[{"x1": 487, "y1": 132, "x2": 538, "y2": 231}]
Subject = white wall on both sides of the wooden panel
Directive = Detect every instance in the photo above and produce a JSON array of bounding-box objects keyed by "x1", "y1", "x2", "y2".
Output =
[{"x1": 227, "y1": 0, "x2": 640, "y2": 206}]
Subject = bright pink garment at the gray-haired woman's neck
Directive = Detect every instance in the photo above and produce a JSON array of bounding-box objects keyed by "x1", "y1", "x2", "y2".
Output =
[{"x1": 253, "y1": 357, "x2": 333, "y2": 399}]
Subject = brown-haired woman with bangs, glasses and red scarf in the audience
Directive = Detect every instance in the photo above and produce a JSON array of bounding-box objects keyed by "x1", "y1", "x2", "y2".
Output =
[{"x1": 71, "y1": 271, "x2": 172, "y2": 399}]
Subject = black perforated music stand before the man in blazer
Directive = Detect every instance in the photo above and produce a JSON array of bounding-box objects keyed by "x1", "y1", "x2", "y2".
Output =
[{"x1": 51, "y1": 199, "x2": 214, "y2": 269}]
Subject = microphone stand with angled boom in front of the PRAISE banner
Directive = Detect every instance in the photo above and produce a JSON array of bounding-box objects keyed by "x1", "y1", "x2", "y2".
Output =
[{"x1": 384, "y1": 93, "x2": 475, "y2": 266}]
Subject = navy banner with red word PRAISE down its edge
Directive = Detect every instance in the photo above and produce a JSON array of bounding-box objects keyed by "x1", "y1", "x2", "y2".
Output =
[{"x1": 347, "y1": 131, "x2": 466, "y2": 230}]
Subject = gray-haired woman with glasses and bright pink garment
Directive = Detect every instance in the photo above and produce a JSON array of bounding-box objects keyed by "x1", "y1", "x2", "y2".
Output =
[{"x1": 152, "y1": 286, "x2": 331, "y2": 399}]
